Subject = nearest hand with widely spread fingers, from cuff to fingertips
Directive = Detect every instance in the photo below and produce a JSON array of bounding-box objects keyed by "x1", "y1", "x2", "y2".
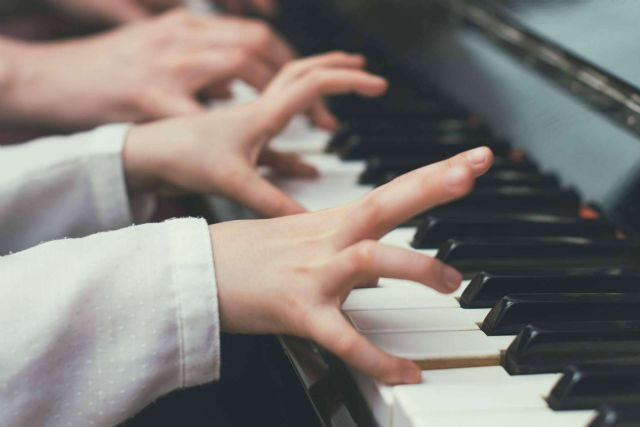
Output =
[{"x1": 211, "y1": 147, "x2": 493, "y2": 384}]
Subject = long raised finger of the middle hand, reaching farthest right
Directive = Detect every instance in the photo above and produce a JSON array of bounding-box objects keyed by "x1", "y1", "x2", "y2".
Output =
[{"x1": 256, "y1": 69, "x2": 387, "y2": 135}]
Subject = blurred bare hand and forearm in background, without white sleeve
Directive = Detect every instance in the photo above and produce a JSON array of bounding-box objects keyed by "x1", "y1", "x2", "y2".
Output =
[{"x1": 0, "y1": 9, "x2": 295, "y2": 129}]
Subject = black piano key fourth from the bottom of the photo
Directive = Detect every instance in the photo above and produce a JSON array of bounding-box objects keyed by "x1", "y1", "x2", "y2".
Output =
[{"x1": 481, "y1": 293, "x2": 640, "y2": 335}]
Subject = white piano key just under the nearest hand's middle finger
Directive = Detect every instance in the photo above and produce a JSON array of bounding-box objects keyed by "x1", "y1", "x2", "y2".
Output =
[{"x1": 342, "y1": 285, "x2": 459, "y2": 311}]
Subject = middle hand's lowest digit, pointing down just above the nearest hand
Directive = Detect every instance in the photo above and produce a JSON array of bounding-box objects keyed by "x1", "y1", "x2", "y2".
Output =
[{"x1": 226, "y1": 169, "x2": 306, "y2": 218}]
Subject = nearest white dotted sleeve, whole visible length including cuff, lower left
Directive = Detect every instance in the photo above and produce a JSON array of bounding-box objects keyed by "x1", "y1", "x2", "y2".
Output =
[{"x1": 0, "y1": 219, "x2": 220, "y2": 426}]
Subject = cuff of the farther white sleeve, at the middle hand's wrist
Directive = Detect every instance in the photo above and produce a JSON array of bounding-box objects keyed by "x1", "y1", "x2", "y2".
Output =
[{"x1": 87, "y1": 124, "x2": 156, "y2": 230}]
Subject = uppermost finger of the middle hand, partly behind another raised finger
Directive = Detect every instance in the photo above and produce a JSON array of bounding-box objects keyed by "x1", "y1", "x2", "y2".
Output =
[{"x1": 274, "y1": 52, "x2": 366, "y2": 90}]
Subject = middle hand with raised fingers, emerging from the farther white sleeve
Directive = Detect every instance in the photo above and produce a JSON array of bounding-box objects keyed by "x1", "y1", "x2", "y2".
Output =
[{"x1": 124, "y1": 52, "x2": 387, "y2": 217}]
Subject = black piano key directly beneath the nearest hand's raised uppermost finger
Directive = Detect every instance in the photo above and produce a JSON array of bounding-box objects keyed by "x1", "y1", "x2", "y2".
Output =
[{"x1": 412, "y1": 214, "x2": 616, "y2": 249}]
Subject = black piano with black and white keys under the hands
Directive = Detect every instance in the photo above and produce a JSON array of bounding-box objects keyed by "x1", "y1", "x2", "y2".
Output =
[{"x1": 159, "y1": 0, "x2": 640, "y2": 427}]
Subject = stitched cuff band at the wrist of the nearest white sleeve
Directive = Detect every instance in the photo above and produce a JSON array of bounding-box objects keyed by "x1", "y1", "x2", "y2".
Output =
[{"x1": 166, "y1": 218, "x2": 220, "y2": 387}]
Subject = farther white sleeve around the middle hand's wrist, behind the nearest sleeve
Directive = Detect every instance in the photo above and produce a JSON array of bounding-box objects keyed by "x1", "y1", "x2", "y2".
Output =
[{"x1": 0, "y1": 124, "x2": 153, "y2": 255}]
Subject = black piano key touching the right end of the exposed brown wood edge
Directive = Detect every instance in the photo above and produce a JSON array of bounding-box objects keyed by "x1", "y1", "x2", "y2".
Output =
[{"x1": 502, "y1": 322, "x2": 640, "y2": 375}]
